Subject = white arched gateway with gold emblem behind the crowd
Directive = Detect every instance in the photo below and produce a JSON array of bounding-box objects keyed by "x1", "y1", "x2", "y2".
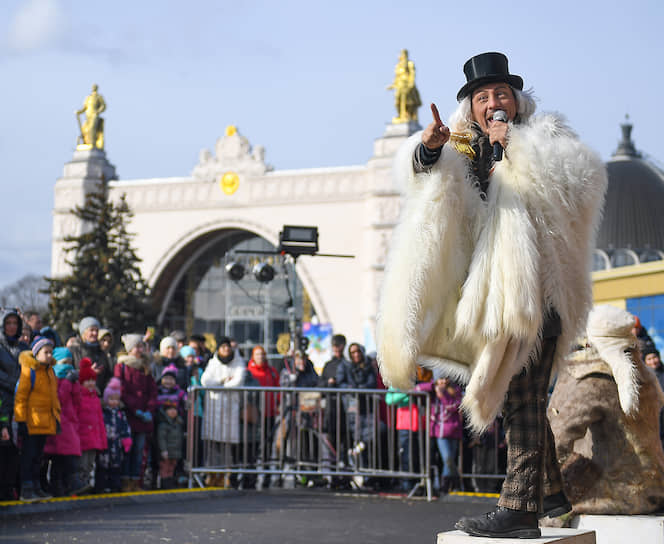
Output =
[{"x1": 51, "y1": 121, "x2": 419, "y2": 350}]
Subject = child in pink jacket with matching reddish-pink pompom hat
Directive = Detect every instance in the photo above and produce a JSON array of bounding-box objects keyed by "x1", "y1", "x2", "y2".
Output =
[{"x1": 78, "y1": 357, "x2": 107, "y2": 484}]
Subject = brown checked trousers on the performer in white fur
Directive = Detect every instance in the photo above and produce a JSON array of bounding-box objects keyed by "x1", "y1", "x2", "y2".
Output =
[{"x1": 498, "y1": 336, "x2": 562, "y2": 512}]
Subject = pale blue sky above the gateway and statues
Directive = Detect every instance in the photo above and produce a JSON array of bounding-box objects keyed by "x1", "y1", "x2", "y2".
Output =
[{"x1": 0, "y1": 0, "x2": 664, "y2": 287}]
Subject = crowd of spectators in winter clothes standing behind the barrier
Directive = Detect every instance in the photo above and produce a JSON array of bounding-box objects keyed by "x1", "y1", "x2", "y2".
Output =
[{"x1": 0, "y1": 309, "x2": 664, "y2": 500}]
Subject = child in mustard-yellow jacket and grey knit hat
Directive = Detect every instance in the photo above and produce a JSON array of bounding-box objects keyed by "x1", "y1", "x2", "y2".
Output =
[{"x1": 14, "y1": 336, "x2": 60, "y2": 500}]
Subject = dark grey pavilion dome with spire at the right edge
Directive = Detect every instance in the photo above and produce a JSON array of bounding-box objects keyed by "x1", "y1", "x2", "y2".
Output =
[{"x1": 594, "y1": 120, "x2": 664, "y2": 270}]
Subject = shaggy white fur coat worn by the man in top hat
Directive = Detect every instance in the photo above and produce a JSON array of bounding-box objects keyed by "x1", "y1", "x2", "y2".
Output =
[{"x1": 377, "y1": 114, "x2": 607, "y2": 431}]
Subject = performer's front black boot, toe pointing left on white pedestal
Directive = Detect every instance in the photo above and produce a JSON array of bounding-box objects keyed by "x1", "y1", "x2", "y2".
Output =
[{"x1": 454, "y1": 506, "x2": 541, "y2": 538}]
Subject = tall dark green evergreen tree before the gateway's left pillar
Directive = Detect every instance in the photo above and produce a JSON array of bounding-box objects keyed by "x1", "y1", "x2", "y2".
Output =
[{"x1": 46, "y1": 187, "x2": 155, "y2": 338}]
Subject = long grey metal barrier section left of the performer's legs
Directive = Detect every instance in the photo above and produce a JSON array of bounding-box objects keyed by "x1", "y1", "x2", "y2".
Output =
[{"x1": 186, "y1": 386, "x2": 432, "y2": 500}]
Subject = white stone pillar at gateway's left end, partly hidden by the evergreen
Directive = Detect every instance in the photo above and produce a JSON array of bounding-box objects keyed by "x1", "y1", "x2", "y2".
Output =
[{"x1": 51, "y1": 149, "x2": 117, "y2": 277}]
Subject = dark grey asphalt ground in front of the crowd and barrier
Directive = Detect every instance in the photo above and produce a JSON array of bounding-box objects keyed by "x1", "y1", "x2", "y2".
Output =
[{"x1": 0, "y1": 489, "x2": 496, "y2": 544}]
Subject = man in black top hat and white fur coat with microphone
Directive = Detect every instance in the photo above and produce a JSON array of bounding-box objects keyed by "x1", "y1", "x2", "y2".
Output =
[{"x1": 378, "y1": 53, "x2": 607, "y2": 538}]
